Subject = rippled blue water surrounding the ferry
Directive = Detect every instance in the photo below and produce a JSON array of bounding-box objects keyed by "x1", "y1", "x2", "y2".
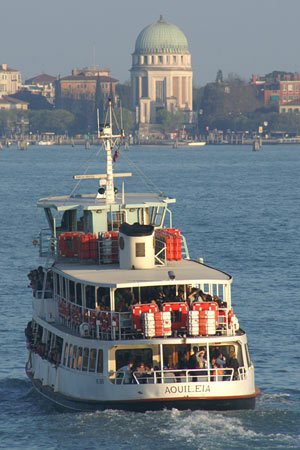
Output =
[{"x1": 0, "y1": 146, "x2": 300, "y2": 450}]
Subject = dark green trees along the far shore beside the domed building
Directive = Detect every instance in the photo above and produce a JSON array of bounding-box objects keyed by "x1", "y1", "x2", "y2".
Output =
[{"x1": 0, "y1": 70, "x2": 300, "y2": 135}]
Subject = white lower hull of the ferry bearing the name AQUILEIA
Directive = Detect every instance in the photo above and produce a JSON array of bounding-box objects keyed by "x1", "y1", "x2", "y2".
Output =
[{"x1": 26, "y1": 354, "x2": 260, "y2": 411}]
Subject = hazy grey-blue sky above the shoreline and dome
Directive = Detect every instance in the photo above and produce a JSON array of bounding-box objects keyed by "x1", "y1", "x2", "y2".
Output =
[{"x1": 0, "y1": 0, "x2": 300, "y2": 86}]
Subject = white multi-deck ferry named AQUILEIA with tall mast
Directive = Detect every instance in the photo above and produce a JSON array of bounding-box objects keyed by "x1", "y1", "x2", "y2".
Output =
[{"x1": 25, "y1": 103, "x2": 260, "y2": 411}]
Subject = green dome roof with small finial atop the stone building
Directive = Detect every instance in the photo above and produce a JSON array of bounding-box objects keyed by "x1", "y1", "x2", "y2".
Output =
[{"x1": 135, "y1": 16, "x2": 189, "y2": 54}]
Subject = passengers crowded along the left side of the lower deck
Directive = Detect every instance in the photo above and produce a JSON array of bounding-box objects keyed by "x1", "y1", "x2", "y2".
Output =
[{"x1": 25, "y1": 321, "x2": 62, "y2": 367}]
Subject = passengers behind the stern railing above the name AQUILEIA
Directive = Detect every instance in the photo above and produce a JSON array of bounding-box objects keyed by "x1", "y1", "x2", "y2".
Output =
[{"x1": 117, "y1": 346, "x2": 239, "y2": 384}]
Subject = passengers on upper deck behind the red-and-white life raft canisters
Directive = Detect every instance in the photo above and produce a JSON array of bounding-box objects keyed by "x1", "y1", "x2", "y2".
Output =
[{"x1": 98, "y1": 286, "x2": 227, "y2": 312}]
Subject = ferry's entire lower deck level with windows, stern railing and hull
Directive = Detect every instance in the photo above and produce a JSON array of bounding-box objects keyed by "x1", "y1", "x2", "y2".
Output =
[{"x1": 26, "y1": 316, "x2": 258, "y2": 410}]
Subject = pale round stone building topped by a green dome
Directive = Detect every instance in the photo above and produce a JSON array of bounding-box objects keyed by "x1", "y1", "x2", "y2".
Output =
[{"x1": 130, "y1": 16, "x2": 193, "y2": 124}]
